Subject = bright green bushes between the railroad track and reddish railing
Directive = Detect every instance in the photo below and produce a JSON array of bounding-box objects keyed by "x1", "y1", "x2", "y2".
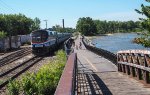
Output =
[{"x1": 7, "y1": 50, "x2": 66, "y2": 95}]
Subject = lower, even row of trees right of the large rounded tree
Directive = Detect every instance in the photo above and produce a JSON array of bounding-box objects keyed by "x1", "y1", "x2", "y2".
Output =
[{"x1": 94, "y1": 20, "x2": 141, "y2": 34}]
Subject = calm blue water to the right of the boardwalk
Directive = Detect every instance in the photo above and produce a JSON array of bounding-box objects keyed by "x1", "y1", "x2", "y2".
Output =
[{"x1": 92, "y1": 33, "x2": 150, "y2": 53}]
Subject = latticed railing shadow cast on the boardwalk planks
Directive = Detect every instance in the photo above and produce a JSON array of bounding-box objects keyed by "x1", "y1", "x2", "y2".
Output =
[{"x1": 77, "y1": 59, "x2": 113, "y2": 95}]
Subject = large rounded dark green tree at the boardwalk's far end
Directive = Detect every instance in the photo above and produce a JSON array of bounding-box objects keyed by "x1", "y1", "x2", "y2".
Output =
[{"x1": 76, "y1": 17, "x2": 97, "y2": 36}]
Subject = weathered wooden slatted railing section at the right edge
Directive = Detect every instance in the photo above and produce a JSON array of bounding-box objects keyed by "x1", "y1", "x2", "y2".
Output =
[{"x1": 117, "y1": 50, "x2": 150, "y2": 84}]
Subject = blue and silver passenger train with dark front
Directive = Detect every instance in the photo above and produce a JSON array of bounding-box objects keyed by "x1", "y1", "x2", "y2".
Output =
[{"x1": 31, "y1": 29, "x2": 71, "y2": 55}]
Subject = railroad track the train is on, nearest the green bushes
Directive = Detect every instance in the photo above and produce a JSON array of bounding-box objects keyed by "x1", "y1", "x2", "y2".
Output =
[{"x1": 0, "y1": 56, "x2": 43, "y2": 89}]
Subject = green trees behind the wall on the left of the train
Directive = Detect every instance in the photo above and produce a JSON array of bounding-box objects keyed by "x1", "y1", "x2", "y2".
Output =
[{"x1": 0, "y1": 14, "x2": 40, "y2": 36}]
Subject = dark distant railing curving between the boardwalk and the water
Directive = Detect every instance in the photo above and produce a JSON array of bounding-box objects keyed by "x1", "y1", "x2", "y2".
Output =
[{"x1": 82, "y1": 39, "x2": 117, "y2": 65}]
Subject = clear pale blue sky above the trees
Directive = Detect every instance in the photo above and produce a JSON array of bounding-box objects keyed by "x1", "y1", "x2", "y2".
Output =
[{"x1": 0, "y1": 0, "x2": 148, "y2": 28}]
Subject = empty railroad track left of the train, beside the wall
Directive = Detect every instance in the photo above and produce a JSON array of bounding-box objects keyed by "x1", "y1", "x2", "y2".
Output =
[{"x1": 0, "y1": 47, "x2": 31, "y2": 67}]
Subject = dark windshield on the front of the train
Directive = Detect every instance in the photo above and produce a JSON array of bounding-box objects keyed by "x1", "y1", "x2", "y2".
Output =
[{"x1": 32, "y1": 30, "x2": 48, "y2": 43}]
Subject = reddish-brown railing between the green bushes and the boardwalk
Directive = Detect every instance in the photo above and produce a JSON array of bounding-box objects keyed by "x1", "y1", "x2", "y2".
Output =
[{"x1": 55, "y1": 53, "x2": 77, "y2": 95}]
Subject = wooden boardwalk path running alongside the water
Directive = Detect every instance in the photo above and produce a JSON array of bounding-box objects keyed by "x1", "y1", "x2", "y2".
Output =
[{"x1": 75, "y1": 38, "x2": 150, "y2": 95}]
